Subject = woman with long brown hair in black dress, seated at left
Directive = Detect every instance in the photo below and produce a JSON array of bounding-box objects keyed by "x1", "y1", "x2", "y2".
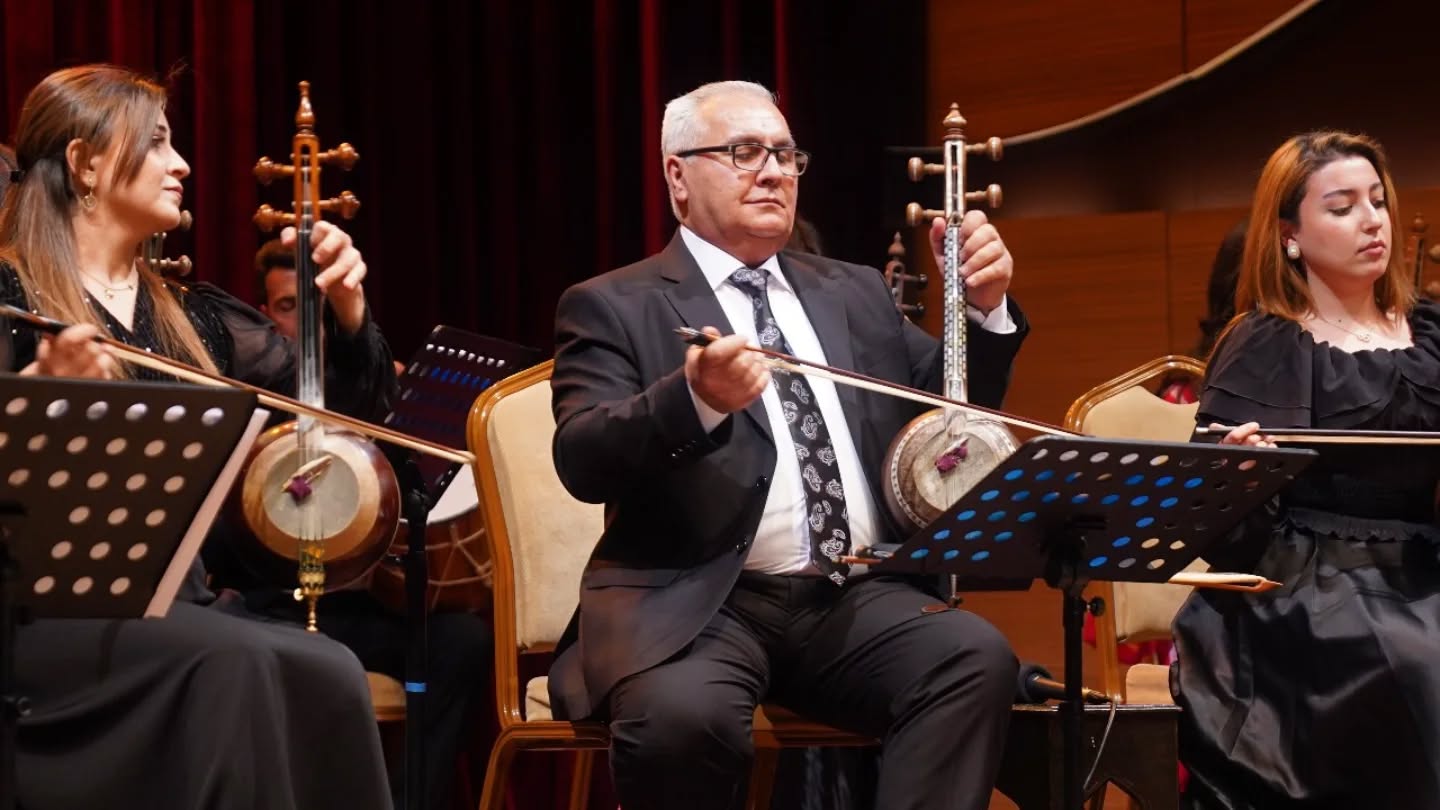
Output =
[{"x1": 0, "y1": 66, "x2": 395, "y2": 810}]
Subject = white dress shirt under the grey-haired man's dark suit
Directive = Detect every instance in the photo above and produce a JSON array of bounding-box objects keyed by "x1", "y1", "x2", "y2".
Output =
[{"x1": 680, "y1": 226, "x2": 1015, "y2": 575}]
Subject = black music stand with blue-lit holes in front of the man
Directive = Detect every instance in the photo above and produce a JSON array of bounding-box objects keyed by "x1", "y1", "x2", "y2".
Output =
[{"x1": 876, "y1": 435, "x2": 1316, "y2": 810}]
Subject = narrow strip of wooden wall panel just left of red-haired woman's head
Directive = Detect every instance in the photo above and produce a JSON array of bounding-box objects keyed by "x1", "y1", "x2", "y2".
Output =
[{"x1": 1157, "y1": 208, "x2": 1247, "y2": 353}]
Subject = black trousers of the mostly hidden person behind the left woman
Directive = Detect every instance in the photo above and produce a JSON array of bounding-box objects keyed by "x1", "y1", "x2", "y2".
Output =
[{"x1": 252, "y1": 591, "x2": 494, "y2": 810}]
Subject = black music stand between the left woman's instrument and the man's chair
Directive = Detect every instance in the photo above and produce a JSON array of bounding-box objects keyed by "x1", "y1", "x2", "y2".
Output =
[{"x1": 383, "y1": 326, "x2": 540, "y2": 810}]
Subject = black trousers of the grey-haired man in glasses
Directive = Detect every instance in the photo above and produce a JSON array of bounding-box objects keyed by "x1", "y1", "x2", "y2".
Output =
[{"x1": 608, "y1": 572, "x2": 1017, "y2": 810}]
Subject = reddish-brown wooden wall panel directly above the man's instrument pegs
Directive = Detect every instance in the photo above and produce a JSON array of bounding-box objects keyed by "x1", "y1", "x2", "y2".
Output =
[{"x1": 926, "y1": 0, "x2": 1182, "y2": 140}]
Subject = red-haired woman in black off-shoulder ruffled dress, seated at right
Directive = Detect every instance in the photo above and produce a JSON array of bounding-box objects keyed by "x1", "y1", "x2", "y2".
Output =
[{"x1": 1172, "y1": 133, "x2": 1440, "y2": 810}]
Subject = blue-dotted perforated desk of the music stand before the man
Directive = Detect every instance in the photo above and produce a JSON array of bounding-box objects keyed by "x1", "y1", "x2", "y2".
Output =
[{"x1": 869, "y1": 437, "x2": 1309, "y2": 582}]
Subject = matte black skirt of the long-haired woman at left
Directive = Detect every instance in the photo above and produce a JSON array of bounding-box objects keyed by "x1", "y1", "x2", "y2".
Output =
[{"x1": 16, "y1": 590, "x2": 390, "y2": 810}]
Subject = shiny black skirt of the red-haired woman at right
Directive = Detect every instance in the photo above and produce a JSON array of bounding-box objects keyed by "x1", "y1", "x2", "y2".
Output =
[{"x1": 1172, "y1": 509, "x2": 1440, "y2": 810}]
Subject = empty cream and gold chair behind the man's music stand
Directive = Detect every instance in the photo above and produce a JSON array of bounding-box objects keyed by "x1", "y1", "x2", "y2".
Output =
[{"x1": 1066, "y1": 355, "x2": 1207, "y2": 695}]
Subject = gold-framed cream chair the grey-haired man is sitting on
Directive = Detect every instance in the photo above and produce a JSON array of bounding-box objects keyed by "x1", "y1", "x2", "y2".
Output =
[{"x1": 467, "y1": 362, "x2": 876, "y2": 810}]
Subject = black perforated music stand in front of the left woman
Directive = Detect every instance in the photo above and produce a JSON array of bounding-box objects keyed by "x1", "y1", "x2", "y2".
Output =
[{"x1": 0, "y1": 375, "x2": 266, "y2": 810}]
